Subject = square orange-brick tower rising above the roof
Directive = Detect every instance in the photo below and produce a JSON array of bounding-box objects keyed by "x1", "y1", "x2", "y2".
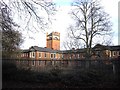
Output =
[{"x1": 46, "y1": 32, "x2": 60, "y2": 50}]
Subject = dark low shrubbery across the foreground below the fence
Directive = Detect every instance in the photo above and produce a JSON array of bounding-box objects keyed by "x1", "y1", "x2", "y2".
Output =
[{"x1": 3, "y1": 63, "x2": 118, "y2": 87}]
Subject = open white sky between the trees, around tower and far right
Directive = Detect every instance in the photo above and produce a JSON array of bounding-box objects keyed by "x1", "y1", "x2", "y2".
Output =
[{"x1": 21, "y1": 0, "x2": 119, "y2": 49}]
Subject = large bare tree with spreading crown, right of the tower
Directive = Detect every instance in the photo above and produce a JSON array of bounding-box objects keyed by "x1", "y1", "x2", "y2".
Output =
[{"x1": 69, "y1": 0, "x2": 112, "y2": 58}]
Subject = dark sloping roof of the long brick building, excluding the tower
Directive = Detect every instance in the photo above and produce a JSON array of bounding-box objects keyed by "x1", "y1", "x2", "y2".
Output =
[{"x1": 22, "y1": 44, "x2": 120, "y2": 54}]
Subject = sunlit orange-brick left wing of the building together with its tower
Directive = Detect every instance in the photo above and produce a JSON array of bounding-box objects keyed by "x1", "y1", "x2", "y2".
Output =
[{"x1": 20, "y1": 32, "x2": 62, "y2": 60}]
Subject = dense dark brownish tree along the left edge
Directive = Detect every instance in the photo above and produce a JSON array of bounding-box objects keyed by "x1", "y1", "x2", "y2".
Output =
[{"x1": 0, "y1": 3, "x2": 23, "y2": 58}]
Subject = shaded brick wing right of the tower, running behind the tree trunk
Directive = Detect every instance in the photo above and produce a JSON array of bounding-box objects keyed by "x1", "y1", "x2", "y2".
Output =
[{"x1": 62, "y1": 44, "x2": 120, "y2": 60}]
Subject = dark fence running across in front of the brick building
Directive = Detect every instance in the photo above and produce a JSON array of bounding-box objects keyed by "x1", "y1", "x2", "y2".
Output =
[{"x1": 2, "y1": 59, "x2": 120, "y2": 74}]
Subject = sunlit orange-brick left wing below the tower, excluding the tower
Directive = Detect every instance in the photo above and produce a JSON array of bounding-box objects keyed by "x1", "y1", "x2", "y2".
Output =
[{"x1": 21, "y1": 46, "x2": 61, "y2": 60}]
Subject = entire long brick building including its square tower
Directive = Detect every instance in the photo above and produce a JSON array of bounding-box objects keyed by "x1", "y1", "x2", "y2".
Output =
[{"x1": 20, "y1": 32, "x2": 120, "y2": 60}]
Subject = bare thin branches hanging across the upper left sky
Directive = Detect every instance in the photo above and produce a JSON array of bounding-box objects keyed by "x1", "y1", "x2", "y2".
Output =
[{"x1": 0, "y1": 0, "x2": 56, "y2": 32}]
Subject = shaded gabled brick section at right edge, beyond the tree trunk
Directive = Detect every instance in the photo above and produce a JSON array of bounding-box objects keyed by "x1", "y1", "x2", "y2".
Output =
[{"x1": 92, "y1": 44, "x2": 120, "y2": 58}]
